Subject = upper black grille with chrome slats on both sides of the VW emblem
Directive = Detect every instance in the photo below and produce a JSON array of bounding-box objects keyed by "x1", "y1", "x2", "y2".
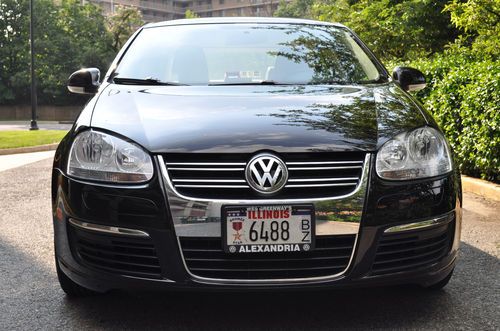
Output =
[{"x1": 164, "y1": 152, "x2": 366, "y2": 200}]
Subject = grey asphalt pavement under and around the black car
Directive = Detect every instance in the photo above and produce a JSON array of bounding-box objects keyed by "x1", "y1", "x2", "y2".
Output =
[{"x1": 0, "y1": 159, "x2": 500, "y2": 330}]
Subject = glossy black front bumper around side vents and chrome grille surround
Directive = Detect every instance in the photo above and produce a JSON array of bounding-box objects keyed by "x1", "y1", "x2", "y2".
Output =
[{"x1": 53, "y1": 154, "x2": 461, "y2": 291}]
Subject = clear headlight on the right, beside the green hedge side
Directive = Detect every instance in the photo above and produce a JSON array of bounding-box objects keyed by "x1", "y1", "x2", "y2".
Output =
[{"x1": 376, "y1": 127, "x2": 452, "y2": 180}]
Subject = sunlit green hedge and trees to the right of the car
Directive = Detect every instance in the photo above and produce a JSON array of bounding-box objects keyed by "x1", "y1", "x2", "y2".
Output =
[{"x1": 276, "y1": 0, "x2": 500, "y2": 182}]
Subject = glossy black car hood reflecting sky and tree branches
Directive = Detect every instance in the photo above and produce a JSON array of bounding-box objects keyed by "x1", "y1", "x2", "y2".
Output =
[{"x1": 91, "y1": 83, "x2": 427, "y2": 153}]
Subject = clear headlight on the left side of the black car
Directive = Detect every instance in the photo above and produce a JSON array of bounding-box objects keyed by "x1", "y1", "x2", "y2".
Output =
[{"x1": 68, "y1": 131, "x2": 153, "y2": 183}]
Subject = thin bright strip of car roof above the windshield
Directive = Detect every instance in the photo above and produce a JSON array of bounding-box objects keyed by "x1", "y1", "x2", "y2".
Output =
[{"x1": 144, "y1": 17, "x2": 345, "y2": 28}]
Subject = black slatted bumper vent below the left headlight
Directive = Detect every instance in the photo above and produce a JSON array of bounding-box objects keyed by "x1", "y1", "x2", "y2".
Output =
[{"x1": 68, "y1": 225, "x2": 161, "y2": 278}]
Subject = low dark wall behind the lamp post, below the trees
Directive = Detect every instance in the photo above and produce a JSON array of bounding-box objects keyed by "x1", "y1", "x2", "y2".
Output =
[{"x1": 0, "y1": 105, "x2": 83, "y2": 121}]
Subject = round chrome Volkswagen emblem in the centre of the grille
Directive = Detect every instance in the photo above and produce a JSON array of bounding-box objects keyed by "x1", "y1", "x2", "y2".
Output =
[{"x1": 245, "y1": 154, "x2": 288, "y2": 194}]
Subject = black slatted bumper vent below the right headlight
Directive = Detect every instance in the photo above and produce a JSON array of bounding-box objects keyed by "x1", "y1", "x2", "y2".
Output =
[{"x1": 372, "y1": 222, "x2": 454, "y2": 275}]
